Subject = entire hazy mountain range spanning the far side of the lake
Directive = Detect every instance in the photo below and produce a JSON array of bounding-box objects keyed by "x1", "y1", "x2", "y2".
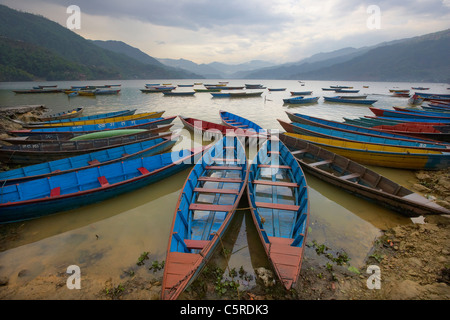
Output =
[{"x1": 0, "y1": 5, "x2": 450, "y2": 83}]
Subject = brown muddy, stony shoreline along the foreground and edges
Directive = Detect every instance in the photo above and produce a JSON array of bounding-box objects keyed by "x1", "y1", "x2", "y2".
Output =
[{"x1": 0, "y1": 106, "x2": 450, "y2": 300}]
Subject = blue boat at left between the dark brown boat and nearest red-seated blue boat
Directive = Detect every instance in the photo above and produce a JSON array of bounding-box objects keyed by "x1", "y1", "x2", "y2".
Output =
[{"x1": 0, "y1": 133, "x2": 179, "y2": 186}]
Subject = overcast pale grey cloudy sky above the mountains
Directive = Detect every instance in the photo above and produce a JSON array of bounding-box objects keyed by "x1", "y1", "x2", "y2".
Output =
[{"x1": 0, "y1": 0, "x2": 450, "y2": 63}]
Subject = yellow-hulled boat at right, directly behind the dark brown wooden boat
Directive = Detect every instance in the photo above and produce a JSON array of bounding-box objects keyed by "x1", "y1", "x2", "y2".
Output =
[{"x1": 283, "y1": 133, "x2": 450, "y2": 170}]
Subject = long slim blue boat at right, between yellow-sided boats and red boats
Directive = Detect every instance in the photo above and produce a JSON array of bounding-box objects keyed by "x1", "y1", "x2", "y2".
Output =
[{"x1": 286, "y1": 112, "x2": 445, "y2": 145}]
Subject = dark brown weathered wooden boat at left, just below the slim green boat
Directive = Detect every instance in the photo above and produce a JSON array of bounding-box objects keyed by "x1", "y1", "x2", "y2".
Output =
[{"x1": 0, "y1": 130, "x2": 171, "y2": 165}]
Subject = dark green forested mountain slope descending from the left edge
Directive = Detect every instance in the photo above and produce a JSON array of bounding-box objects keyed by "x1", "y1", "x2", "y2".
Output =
[{"x1": 0, "y1": 5, "x2": 201, "y2": 81}]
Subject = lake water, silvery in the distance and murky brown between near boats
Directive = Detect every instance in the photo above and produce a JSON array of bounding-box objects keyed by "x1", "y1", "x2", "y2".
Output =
[{"x1": 0, "y1": 79, "x2": 448, "y2": 298}]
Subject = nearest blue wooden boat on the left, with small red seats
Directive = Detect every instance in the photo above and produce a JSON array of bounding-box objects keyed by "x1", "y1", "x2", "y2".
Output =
[{"x1": 0, "y1": 146, "x2": 201, "y2": 223}]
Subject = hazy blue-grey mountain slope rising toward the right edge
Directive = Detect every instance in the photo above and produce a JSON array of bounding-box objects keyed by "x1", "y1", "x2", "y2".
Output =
[{"x1": 242, "y1": 29, "x2": 450, "y2": 82}]
